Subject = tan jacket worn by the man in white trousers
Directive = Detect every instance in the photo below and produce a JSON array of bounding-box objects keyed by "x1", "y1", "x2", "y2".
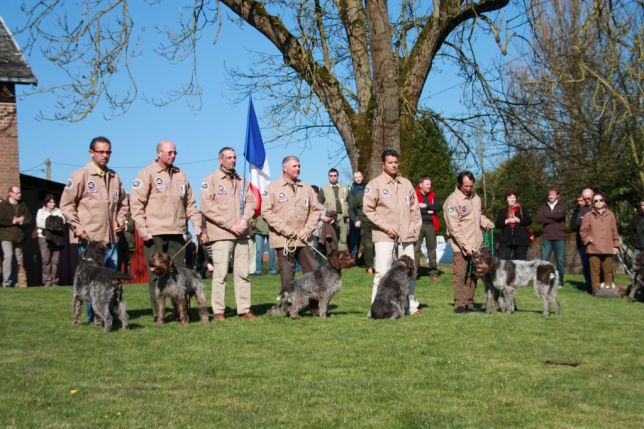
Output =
[{"x1": 362, "y1": 172, "x2": 422, "y2": 243}]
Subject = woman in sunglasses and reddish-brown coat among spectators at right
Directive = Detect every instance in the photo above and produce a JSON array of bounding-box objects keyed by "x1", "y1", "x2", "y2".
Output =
[{"x1": 580, "y1": 194, "x2": 619, "y2": 295}]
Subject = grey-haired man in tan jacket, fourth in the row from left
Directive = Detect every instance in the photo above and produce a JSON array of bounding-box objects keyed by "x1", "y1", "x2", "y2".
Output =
[{"x1": 262, "y1": 156, "x2": 321, "y2": 288}]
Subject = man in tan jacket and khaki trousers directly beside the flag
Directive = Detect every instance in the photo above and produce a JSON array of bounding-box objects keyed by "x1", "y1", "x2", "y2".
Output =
[{"x1": 200, "y1": 147, "x2": 257, "y2": 320}]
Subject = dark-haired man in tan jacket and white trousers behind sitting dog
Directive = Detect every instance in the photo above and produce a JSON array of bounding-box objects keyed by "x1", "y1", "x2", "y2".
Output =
[{"x1": 362, "y1": 149, "x2": 422, "y2": 316}]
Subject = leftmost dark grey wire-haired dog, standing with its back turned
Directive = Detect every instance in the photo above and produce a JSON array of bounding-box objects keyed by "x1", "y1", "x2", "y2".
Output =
[{"x1": 72, "y1": 241, "x2": 134, "y2": 332}]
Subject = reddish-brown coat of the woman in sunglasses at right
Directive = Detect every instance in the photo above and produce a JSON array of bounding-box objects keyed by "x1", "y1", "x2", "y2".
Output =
[{"x1": 579, "y1": 209, "x2": 619, "y2": 255}]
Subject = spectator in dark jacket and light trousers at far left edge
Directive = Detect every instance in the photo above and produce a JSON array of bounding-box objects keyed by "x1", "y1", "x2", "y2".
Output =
[{"x1": 0, "y1": 186, "x2": 31, "y2": 287}]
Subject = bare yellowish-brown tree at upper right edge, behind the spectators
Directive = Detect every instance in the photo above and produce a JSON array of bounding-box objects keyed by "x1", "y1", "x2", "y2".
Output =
[{"x1": 503, "y1": 0, "x2": 644, "y2": 198}]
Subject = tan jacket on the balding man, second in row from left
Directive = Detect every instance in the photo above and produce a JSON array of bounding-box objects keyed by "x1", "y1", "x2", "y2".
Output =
[{"x1": 130, "y1": 161, "x2": 201, "y2": 237}]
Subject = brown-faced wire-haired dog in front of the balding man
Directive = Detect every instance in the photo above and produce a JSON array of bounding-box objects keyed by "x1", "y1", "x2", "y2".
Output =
[{"x1": 148, "y1": 251, "x2": 208, "y2": 325}]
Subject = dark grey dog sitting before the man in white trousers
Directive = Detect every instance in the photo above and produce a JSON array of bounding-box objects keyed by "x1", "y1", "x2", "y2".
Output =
[{"x1": 370, "y1": 255, "x2": 416, "y2": 319}]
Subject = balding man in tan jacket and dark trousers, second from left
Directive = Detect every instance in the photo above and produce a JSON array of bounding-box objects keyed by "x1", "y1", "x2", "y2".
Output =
[{"x1": 130, "y1": 141, "x2": 201, "y2": 318}]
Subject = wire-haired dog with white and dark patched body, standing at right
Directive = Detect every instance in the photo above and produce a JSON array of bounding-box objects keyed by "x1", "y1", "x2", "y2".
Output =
[{"x1": 472, "y1": 247, "x2": 561, "y2": 317}]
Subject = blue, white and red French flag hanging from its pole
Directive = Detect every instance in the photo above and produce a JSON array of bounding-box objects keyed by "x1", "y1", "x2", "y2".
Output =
[{"x1": 244, "y1": 98, "x2": 271, "y2": 217}]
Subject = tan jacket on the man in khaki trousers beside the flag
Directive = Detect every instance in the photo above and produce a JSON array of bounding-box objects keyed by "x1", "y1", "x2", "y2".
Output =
[{"x1": 200, "y1": 168, "x2": 257, "y2": 241}]
